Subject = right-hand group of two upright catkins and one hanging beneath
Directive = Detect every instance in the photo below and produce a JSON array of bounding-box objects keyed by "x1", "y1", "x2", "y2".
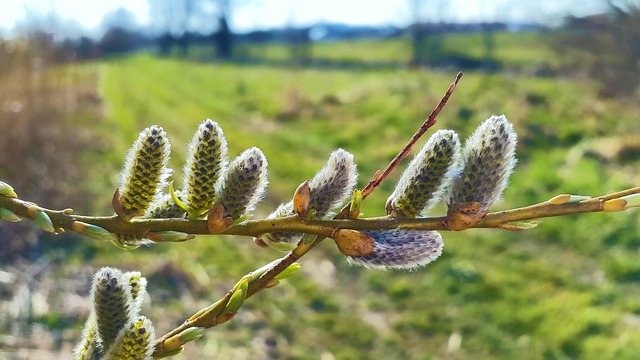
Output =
[{"x1": 349, "y1": 115, "x2": 516, "y2": 269}]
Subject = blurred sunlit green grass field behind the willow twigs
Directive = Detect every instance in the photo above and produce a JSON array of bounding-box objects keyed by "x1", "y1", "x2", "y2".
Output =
[{"x1": 3, "y1": 32, "x2": 640, "y2": 359}]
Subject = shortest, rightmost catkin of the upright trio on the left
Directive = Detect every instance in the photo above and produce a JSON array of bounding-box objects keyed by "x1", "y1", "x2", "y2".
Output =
[{"x1": 216, "y1": 147, "x2": 268, "y2": 220}]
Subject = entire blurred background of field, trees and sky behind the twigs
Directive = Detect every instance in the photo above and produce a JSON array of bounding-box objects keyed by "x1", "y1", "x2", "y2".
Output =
[{"x1": 0, "y1": 0, "x2": 640, "y2": 360}]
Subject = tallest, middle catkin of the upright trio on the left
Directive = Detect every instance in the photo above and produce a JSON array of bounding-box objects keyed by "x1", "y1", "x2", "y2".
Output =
[{"x1": 183, "y1": 119, "x2": 227, "y2": 213}]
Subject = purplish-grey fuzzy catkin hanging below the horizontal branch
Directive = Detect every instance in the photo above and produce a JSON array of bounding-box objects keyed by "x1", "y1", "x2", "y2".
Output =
[{"x1": 348, "y1": 229, "x2": 444, "y2": 270}]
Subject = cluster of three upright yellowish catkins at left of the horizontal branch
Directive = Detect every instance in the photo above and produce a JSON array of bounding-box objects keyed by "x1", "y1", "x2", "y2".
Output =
[{"x1": 112, "y1": 119, "x2": 268, "y2": 249}]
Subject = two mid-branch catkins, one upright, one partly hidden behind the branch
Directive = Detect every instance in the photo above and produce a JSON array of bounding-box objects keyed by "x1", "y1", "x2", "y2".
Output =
[{"x1": 263, "y1": 149, "x2": 358, "y2": 250}]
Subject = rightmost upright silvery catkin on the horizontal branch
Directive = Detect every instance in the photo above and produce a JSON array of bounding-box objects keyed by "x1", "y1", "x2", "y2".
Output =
[{"x1": 449, "y1": 115, "x2": 517, "y2": 212}]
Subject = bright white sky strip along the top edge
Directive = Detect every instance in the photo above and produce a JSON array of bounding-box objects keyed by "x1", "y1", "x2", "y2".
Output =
[{"x1": 0, "y1": 0, "x2": 604, "y2": 32}]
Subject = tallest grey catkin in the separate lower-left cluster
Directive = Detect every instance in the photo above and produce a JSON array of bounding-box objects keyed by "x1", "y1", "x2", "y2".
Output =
[{"x1": 91, "y1": 267, "x2": 136, "y2": 349}]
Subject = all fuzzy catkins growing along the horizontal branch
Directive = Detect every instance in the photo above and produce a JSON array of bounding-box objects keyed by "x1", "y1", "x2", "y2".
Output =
[{"x1": 107, "y1": 115, "x2": 517, "y2": 269}]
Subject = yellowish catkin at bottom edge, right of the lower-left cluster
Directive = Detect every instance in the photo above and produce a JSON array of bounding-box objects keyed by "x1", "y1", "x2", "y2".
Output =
[{"x1": 104, "y1": 316, "x2": 156, "y2": 360}]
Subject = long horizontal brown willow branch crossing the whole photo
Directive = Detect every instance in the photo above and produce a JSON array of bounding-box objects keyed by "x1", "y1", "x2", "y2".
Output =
[{"x1": 0, "y1": 187, "x2": 640, "y2": 239}]
